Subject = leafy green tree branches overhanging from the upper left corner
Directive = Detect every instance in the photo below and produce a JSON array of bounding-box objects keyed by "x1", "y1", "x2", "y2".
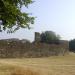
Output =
[{"x1": 0, "y1": 0, "x2": 34, "y2": 32}]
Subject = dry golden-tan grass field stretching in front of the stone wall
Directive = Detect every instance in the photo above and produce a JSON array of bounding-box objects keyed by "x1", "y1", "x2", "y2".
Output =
[{"x1": 0, "y1": 53, "x2": 75, "y2": 75}]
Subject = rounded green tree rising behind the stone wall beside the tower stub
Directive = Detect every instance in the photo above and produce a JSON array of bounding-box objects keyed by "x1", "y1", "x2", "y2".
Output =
[{"x1": 41, "y1": 31, "x2": 60, "y2": 44}]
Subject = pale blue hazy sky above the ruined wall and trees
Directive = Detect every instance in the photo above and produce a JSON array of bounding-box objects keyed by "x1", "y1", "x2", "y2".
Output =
[{"x1": 0, "y1": 0, "x2": 75, "y2": 41}]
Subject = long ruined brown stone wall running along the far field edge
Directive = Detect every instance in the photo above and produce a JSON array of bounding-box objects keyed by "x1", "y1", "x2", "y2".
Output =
[{"x1": 0, "y1": 41, "x2": 69, "y2": 58}]
